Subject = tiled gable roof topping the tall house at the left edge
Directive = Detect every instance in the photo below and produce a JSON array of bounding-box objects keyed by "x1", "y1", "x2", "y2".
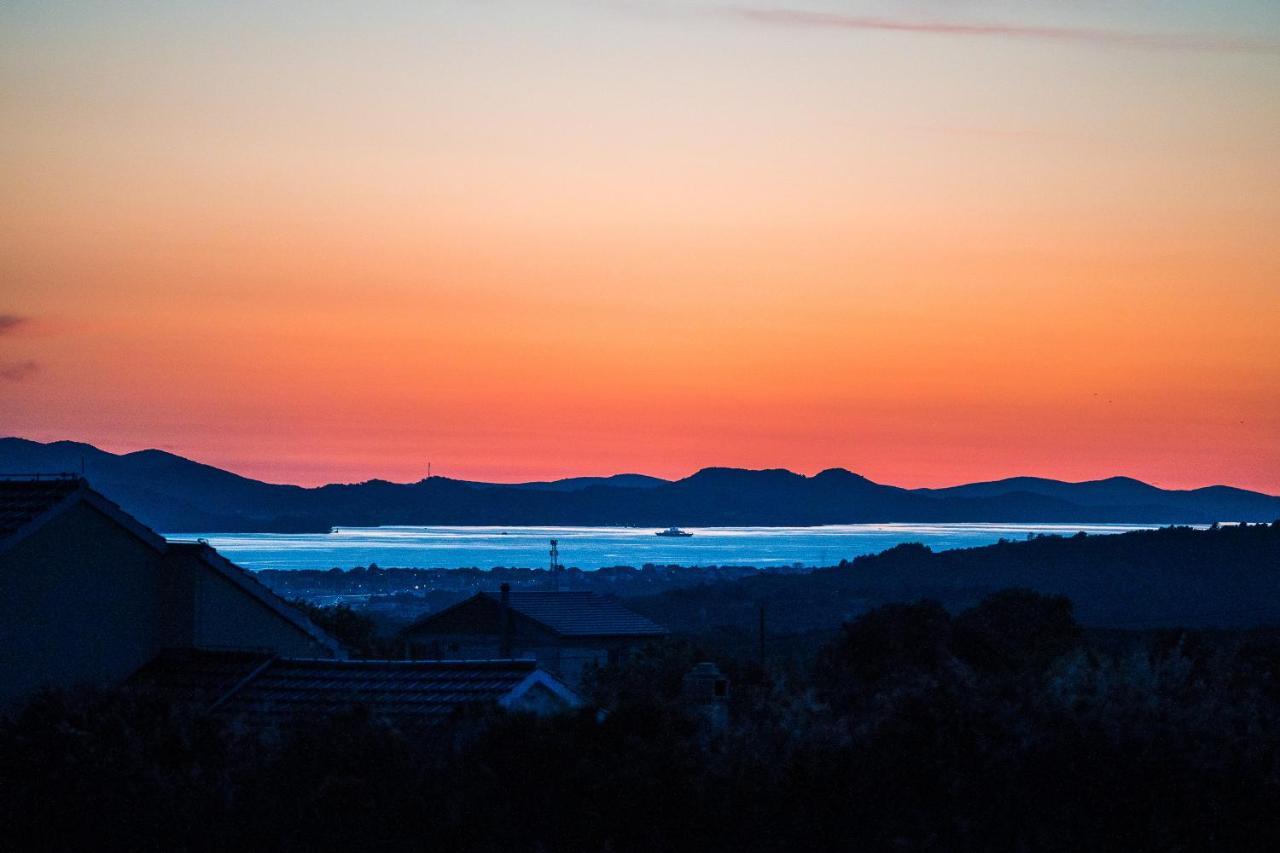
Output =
[{"x1": 0, "y1": 475, "x2": 165, "y2": 552}]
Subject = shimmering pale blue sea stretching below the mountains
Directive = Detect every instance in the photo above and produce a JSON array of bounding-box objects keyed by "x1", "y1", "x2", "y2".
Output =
[{"x1": 162, "y1": 524, "x2": 1172, "y2": 570}]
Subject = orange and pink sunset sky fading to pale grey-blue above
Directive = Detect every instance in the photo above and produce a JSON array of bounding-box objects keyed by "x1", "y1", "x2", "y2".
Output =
[{"x1": 0, "y1": 0, "x2": 1280, "y2": 484}]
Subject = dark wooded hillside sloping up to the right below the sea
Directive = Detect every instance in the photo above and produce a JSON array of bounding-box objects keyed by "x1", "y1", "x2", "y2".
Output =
[{"x1": 628, "y1": 523, "x2": 1280, "y2": 634}]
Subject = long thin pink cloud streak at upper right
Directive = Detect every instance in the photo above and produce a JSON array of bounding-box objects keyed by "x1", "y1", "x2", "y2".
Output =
[{"x1": 727, "y1": 6, "x2": 1280, "y2": 55}]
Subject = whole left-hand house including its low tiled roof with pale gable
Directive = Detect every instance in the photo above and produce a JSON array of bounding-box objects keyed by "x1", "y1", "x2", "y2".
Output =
[{"x1": 0, "y1": 476, "x2": 581, "y2": 727}]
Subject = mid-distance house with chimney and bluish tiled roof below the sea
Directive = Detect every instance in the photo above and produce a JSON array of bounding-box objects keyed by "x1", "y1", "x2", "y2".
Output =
[{"x1": 402, "y1": 584, "x2": 668, "y2": 685}]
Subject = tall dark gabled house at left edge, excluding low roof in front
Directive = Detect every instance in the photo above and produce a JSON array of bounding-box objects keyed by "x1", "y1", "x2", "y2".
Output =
[{"x1": 0, "y1": 476, "x2": 344, "y2": 707}]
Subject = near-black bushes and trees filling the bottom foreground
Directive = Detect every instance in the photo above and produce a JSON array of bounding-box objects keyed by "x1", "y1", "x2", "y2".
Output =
[{"x1": 0, "y1": 590, "x2": 1280, "y2": 850}]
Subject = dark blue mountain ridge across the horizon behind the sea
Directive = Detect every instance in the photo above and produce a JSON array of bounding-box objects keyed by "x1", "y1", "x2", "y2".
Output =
[{"x1": 0, "y1": 438, "x2": 1280, "y2": 533}]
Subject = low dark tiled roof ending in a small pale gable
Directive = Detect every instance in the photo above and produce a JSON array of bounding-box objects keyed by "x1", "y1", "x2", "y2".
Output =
[{"x1": 129, "y1": 649, "x2": 581, "y2": 726}]
